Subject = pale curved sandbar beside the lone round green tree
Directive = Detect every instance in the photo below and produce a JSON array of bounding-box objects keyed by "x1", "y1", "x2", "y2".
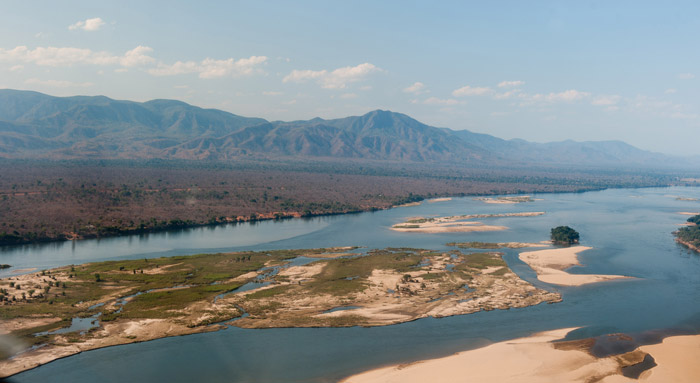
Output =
[{"x1": 519, "y1": 246, "x2": 630, "y2": 286}]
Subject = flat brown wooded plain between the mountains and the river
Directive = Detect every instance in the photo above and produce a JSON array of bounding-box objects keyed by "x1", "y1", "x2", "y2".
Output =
[{"x1": 5, "y1": 159, "x2": 660, "y2": 250}]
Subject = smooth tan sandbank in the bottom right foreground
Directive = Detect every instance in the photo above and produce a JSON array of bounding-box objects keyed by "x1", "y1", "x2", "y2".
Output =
[{"x1": 342, "y1": 328, "x2": 700, "y2": 383}]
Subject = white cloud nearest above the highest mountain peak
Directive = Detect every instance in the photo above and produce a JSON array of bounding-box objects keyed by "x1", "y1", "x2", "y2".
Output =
[{"x1": 282, "y1": 63, "x2": 382, "y2": 89}]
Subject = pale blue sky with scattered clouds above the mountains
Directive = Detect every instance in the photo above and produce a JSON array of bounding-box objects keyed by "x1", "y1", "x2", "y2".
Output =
[{"x1": 0, "y1": 0, "x2": 700, "y2": 155}]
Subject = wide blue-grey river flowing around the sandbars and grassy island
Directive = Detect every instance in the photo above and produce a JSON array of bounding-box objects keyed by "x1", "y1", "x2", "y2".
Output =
[{"x1": 0, "y1": 187, "x2": 700, "y2": 383}]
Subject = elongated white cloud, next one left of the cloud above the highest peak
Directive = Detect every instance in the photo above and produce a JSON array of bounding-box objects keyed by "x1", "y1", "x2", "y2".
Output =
[{"x1": 148, "y1": 56, "x2": 267, "y2": 79}]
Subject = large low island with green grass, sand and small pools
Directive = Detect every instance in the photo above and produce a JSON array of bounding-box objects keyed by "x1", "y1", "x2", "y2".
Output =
[{"x1": 0, "y1": 247, "x2": 561, "y2": 376}]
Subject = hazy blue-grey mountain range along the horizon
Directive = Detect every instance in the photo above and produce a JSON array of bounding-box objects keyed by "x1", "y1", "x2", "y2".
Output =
[{"x1": 0, "y1": 90, "x2": 684, "y2": 165}]
